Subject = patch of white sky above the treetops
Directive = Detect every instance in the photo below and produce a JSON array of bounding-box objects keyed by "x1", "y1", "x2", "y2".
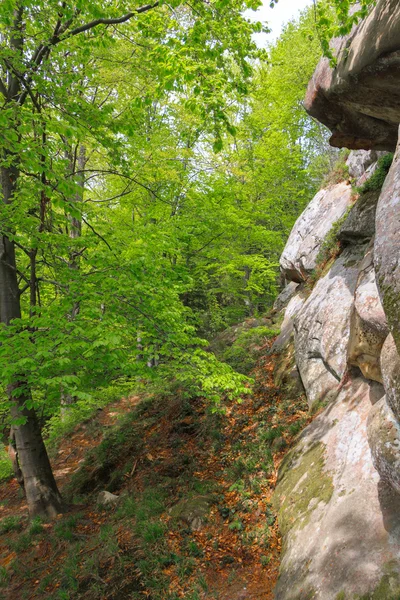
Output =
[{"x1": 247, "y1": 0, "x2": 312, "y2": 46}]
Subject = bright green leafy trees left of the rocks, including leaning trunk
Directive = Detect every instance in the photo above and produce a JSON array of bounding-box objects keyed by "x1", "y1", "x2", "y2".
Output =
[{"x1": 0, "y1": 0, "x2": 340, "y2": 514}]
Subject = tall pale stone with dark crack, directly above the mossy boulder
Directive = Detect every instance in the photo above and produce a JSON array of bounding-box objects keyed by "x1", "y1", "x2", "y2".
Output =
[{"x1": 295, "y1": 246, "x2": 365, "y2": 406}]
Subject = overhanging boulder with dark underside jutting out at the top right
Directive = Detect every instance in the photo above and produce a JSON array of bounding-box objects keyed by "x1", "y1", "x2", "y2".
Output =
[{"x1": 305, "y1": 0, "x2": 400, "y2": 151}]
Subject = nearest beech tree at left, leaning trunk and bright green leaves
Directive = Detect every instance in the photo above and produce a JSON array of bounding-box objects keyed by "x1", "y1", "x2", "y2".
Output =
[{"x1": 0, "y1": 0, "x2": 260, "y2": 517}]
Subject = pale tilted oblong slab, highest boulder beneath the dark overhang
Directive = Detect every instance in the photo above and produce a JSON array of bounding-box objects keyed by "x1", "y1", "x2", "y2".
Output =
[{"x1": 280, "y1": 182, "x2": 352, "y2": 282}]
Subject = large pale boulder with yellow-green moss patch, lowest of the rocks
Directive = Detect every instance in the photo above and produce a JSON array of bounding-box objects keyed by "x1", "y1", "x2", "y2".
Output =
[{"x1": 274, "y1": 377, "x2": 400, "y2": 600}]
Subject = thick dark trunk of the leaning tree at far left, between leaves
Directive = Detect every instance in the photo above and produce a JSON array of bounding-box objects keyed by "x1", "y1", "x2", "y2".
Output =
[{"x1": 0, "y1": 168, "x2": 63, "y2": 517}]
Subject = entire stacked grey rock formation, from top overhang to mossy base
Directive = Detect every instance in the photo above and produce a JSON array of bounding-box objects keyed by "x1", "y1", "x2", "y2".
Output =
[{"x1": 273, "y1": 0, "x2": 400, "y2": 588}]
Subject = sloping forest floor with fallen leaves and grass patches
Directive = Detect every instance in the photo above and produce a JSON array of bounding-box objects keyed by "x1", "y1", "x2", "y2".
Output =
[{"x1": 0, "y1": 340, "x2": 310, "y2": 600}]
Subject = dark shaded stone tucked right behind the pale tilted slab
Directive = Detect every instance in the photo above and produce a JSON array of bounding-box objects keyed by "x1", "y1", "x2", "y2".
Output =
[{"x1": 338, "y1": 191, "x2": 379, "y2": 244}]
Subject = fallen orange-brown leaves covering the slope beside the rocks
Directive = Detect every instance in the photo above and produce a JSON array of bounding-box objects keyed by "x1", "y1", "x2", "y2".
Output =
[{"x1": 0, "y1": 344, "x2": 309, "y2": 600}]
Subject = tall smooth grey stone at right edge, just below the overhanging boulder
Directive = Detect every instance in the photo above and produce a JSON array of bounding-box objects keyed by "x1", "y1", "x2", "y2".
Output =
[{"x1": 374, "y1": 130, "x2": 400, "y2": 352}]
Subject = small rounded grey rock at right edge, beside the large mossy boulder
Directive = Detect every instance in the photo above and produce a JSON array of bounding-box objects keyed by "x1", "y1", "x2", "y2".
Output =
[{"x1": 368, "y1": 397, "x2": 400, "y2": 494}]
